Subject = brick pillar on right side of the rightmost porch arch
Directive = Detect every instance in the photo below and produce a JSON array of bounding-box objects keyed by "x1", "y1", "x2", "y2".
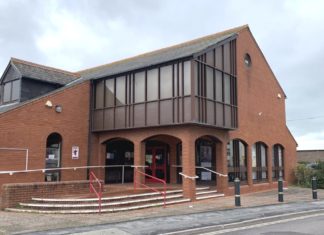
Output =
[{"x1": 216, "y1": 142, "x2": 228, "y2": 193}]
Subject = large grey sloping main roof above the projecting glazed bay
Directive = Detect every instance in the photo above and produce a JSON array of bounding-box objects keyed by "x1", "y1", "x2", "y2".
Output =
[{"x1": 78, "y1": 25, "x2": 248, "y2": 79}]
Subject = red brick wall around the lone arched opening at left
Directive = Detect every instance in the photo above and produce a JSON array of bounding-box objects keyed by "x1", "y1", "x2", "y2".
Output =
[{"x1": 0, "y1": 82, "x2": 90, "y2": 186}]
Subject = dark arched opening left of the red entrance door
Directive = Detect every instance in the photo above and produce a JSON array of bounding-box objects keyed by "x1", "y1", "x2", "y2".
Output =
[{"x1": 105, "y1": 138, "x2": 134, "y2": 183}]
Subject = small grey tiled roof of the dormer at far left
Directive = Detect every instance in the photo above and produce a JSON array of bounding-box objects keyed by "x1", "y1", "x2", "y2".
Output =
[{"x1": 10, "y1": 58, "x2": 80, "y2": 85}]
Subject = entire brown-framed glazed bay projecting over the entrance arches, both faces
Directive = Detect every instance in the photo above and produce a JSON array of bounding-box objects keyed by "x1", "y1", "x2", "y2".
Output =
[{"x1": 92, "y1": 40, "x2": 238, "y2": 131}]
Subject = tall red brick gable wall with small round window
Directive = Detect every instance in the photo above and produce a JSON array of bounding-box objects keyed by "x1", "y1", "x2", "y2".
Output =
[{"x1": 230, "y1": 29, "x2": 297, "y2": 182}]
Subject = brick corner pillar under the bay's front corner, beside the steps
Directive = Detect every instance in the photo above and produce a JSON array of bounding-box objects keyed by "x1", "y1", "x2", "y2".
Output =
[{"x1": 182, "y1": 134, "x2": 196, "y2": 201}]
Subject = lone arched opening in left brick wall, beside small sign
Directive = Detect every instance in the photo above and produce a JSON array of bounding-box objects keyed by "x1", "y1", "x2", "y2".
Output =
[{"x1": 45, "y1": 133, "x2": 62, "y2": 182}]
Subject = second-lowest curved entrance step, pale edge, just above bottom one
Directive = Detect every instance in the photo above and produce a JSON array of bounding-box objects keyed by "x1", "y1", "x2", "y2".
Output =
[{"x1": 19, "y1": 194, "x2": 182, "y2": 209}]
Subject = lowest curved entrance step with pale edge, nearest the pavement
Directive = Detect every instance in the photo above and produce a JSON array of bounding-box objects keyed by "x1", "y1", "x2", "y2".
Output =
[{"x1": 5, "y1": 199, "x2": 190, "y2": 214}]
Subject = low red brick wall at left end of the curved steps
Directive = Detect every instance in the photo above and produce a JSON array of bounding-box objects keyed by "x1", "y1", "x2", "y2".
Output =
[{"x1": 0, "y1": 180, "x2": 89, "y2": 209}]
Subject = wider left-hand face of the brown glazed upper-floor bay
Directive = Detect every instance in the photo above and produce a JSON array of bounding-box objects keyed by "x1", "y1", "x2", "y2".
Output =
[{"x1": 92, "y1": 60, "x2": 192, "y2": 130}]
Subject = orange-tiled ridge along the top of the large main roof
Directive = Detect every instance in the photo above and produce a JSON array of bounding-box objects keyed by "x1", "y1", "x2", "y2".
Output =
[{"x1": 77, "y1": 24, "x2": 249, "y2": 74}]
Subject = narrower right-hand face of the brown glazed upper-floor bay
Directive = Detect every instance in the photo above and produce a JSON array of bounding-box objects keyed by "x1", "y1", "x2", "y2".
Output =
[{"x1": 194, "y1": 41, "x2": 238, "y2": 129}]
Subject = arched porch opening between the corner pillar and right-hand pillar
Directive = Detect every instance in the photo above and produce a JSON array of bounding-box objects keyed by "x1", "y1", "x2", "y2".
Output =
[{"x1": 196, "y1": 136, "x2": 220, "y2": 185}]
